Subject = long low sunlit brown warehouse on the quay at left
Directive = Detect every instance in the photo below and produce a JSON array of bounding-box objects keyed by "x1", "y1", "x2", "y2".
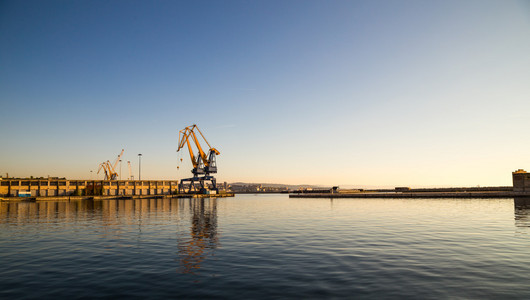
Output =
[{"x1": 0, "y1": 178, "x2": 178, "y2": 197}]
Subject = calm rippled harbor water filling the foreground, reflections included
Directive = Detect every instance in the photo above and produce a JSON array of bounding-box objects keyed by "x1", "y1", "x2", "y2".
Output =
[{"x1": 0, "y1": 195, "x2": 530, "y2": 299}]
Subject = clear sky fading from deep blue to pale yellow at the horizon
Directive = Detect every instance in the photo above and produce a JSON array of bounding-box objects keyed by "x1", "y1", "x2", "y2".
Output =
[{"x1": 0, "y1": 0, "x2": 530, "y2": 187}]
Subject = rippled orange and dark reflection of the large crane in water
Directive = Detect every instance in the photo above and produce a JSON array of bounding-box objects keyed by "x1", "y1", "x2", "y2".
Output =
[{"x1": 177, "y1": 198, "x2": 219, "y2": 274}]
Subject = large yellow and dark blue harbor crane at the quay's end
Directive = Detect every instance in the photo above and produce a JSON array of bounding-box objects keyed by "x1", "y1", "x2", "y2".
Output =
[{"x1": 177, "y1": 124, "x2": 220, "y2": 193}]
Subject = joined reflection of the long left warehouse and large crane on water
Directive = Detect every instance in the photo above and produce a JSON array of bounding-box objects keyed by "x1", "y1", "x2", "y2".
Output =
[{"x1": 0, "y1": 199, "x2": 218, "y2": 274}]
